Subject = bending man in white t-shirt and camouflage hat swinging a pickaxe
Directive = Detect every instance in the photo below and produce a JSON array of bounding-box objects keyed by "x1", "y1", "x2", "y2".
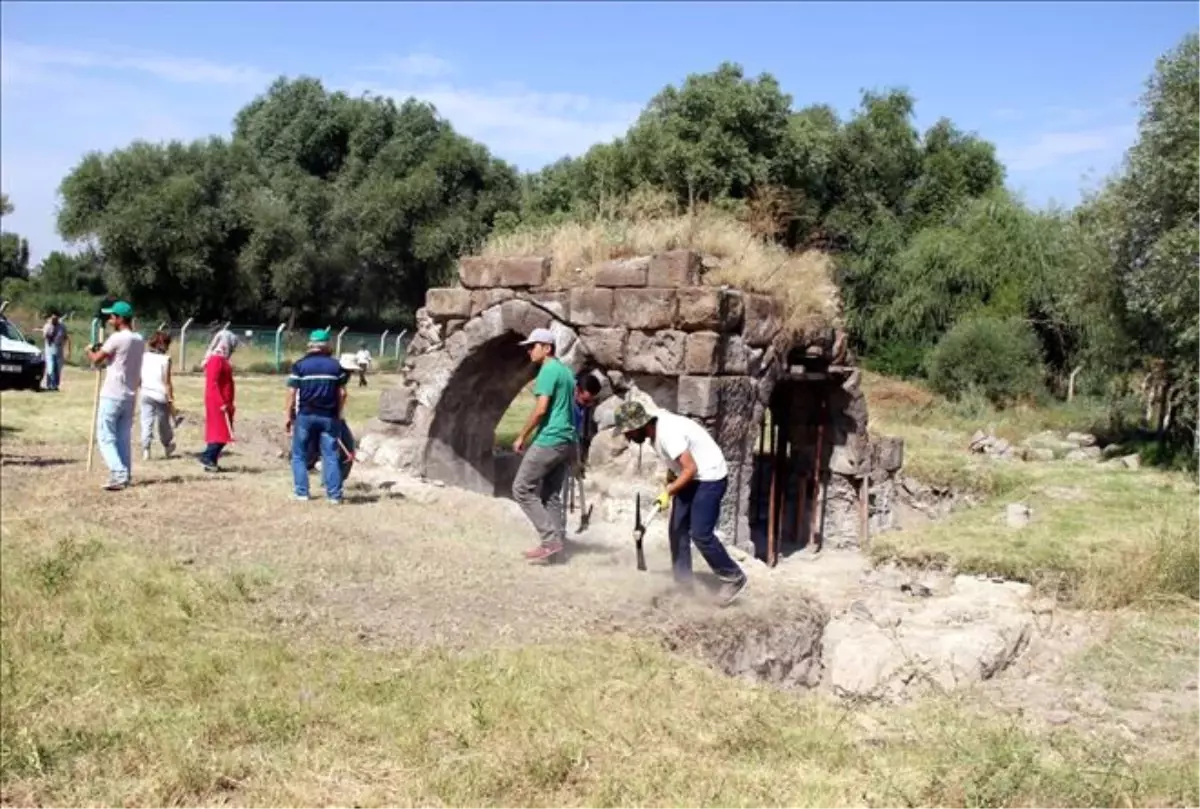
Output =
[{"x1": 613, "y1": 401, "x2": 746, "y2": 606}]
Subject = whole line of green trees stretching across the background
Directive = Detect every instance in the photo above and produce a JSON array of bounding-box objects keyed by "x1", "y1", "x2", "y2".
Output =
[{"x1": 0, "y1": 34, "x2": 1200, "y2": 456}]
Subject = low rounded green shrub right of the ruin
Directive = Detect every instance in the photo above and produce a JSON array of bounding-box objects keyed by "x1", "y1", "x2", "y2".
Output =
[{"x1": 926, "y1": 317, "x2": 1043, "y2": 407}]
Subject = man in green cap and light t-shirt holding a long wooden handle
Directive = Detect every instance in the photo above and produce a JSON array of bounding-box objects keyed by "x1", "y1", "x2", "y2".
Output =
[{"x1": 88, "y1": 300, "x2": 145, "y2": 492}]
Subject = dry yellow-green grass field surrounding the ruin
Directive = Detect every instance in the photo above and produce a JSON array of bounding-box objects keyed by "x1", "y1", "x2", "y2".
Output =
[{"x1": 0, "y1": 370, "x2": 1200, "y2": 808}]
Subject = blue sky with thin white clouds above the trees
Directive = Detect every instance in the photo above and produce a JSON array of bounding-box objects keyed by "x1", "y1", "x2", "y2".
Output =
[{"x1": 0, "y1": 1, "x2": 1200, "y2": 262}]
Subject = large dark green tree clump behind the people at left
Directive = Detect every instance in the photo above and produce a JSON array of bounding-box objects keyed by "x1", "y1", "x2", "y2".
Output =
[{"x1": 59, "y1": 78, "x2": 520, "y2": 322}]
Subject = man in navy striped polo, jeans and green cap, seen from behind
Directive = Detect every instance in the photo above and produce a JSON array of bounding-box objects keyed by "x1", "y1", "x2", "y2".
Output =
[{"x1": 287, "y1": 329, "x2": 349, "y2": 505}]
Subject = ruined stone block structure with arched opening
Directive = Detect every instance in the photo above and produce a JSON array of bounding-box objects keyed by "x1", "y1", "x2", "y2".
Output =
[{"x1": 358, "y1": 250, "x2": 902, "y2": 551}]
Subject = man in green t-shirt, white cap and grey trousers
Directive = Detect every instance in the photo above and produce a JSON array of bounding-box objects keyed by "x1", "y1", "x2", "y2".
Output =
[{"x1": 512, "y1": 329, "x2": 576, "y2": 562}]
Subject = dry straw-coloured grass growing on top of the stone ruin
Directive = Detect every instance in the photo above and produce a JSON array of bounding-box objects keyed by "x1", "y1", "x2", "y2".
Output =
[{"x1": 482, "y1": 208, "x2": 839, "y2": 331}]
